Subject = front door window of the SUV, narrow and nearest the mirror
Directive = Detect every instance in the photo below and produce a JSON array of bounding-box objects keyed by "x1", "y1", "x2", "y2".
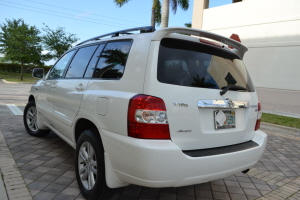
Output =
[{"x1": 48, "y1": 51, "x2": 75, "y2": 79}]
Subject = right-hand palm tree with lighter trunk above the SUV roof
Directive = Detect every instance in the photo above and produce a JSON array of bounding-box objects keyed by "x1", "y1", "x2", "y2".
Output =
[{"x1": 161, "y1": 0, "x2": 189, "y2": 28}]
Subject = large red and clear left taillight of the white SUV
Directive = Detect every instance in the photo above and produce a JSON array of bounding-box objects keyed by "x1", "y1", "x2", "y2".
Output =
[{"x1": 127, "y1": 94, "x2": 170, "y2": 139}]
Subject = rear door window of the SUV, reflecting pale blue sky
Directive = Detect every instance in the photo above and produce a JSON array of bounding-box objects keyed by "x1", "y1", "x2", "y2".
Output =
[{"x1": 66, "y1": 45, "x2": 98, "y2": 78}]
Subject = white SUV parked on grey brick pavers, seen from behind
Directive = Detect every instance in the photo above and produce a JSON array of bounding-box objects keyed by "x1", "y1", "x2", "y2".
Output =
[{"x1": 24, "y1": 27, "x2": 267, "y2": 199}]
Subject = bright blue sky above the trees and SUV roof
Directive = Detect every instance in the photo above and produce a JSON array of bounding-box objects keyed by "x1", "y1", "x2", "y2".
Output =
[{"x1": 0, "y1": 0, "x2": 232, "y2": 63}]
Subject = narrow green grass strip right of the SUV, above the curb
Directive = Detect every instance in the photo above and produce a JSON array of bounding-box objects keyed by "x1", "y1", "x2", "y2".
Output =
[{"x1": 261, "y1": 113, "x2": 300, "y2": 129}]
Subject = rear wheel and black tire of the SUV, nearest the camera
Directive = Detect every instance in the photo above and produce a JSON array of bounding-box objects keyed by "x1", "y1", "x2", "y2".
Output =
[{"x1": 75, "y1": 129, "x2": 114, "y2": 200}]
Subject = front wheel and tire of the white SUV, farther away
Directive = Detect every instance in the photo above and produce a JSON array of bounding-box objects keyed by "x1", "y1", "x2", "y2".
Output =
[{"x1": 23, "y1": 101, "x2": 50, "y2": 137}]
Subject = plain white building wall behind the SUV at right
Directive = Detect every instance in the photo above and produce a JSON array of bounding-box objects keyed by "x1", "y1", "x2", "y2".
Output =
[{"x1": 202, "y1": 0, "x2": 300, "y2": 91}]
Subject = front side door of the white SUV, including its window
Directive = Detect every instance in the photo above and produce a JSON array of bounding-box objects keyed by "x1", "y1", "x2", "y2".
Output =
[{"x1": 36, "y1": 51, "x2": 75, "y2": 126}]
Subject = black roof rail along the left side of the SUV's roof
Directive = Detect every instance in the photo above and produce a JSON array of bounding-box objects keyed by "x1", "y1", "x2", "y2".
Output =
[{"x1": 76, "y1": 26, "x2": 155, "y2": 46}]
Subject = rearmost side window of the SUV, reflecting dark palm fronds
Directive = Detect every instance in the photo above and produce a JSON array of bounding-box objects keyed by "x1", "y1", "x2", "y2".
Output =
[{"x1": 93, "y1": 41, "x2": 132, "y2": 79}]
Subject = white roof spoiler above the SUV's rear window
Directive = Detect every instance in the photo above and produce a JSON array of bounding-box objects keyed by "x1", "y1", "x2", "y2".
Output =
[{"x1": 152, "y1": 27, "x2": 248, "y2": 58}]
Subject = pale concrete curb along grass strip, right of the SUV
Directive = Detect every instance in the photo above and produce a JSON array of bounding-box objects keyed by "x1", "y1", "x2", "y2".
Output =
[{"x1": 260, "y1": 122, "x2": 300, "y2": 138}]
